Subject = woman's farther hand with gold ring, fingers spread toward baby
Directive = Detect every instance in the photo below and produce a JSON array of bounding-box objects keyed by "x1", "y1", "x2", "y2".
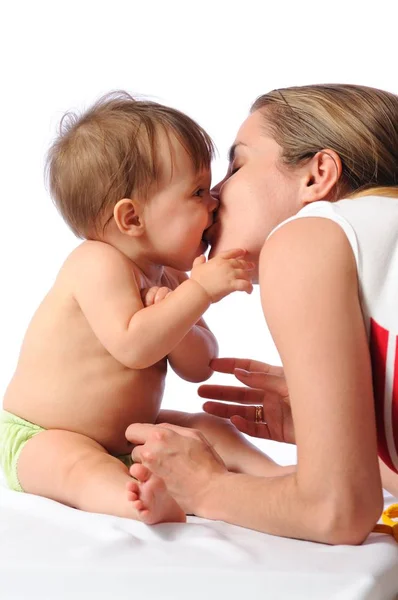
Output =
[{"x1": 198, "y1": 358, "x2": 295, "y2": 444}]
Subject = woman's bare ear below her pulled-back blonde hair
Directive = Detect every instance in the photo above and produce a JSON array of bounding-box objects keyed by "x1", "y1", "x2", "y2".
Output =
[{"x1": 302, "y1": 149, "x2": 343, "y2": 205}]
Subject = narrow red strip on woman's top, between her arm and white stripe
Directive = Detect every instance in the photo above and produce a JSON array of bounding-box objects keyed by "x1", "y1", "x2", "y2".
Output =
[{"x1": 370, "y1": 319, "x2": 396, "y2": 471}]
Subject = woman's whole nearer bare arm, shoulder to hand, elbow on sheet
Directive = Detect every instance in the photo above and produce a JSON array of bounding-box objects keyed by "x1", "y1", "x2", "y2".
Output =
[{"x1": 128, "y1": 219, "x2": 382, "y2": 544}]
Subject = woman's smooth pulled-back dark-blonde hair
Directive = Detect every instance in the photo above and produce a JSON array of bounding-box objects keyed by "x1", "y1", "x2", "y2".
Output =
[{"x1": 251, "y1": 84, "x2": 398, "y2": 198}]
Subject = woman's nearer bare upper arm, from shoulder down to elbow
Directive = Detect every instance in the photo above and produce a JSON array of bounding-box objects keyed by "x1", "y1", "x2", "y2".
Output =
[{"x1": 252, "y1": 218, "x2": 382, "y2": 539}]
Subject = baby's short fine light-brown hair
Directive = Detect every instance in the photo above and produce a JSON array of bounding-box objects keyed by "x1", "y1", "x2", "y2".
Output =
[{"x1": 46, "y1": 91, "x2": 214, "y2": 238}]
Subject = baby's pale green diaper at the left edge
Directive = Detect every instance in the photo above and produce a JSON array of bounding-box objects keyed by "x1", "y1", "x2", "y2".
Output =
[{"x1": 0, "y1": 410, "x2": 133, "y2": 492}]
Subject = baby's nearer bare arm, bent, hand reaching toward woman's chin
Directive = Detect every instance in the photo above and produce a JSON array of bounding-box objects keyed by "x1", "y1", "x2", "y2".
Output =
[{"x1": 69, "y1": 242, "x2": 250, "y2": 369}]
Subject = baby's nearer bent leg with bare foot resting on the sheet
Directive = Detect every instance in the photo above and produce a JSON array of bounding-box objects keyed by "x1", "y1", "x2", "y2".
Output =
[{"x1": 18, "y1": 430, "x2": 185, "y2": 524}]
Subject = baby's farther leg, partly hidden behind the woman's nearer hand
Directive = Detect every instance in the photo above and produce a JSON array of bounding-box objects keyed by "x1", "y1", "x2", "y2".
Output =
[{"x1": 157, "y1": 410, "x2": 294, "y2": 477}]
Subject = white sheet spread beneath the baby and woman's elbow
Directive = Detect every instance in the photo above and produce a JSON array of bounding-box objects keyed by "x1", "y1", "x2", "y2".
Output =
[{"x1": 0, "y1": 472, "x2": 398, "y2": 600}]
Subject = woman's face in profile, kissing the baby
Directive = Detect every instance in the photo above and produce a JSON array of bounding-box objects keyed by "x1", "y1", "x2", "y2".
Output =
[{"x1": 209, "y1": 111, "x2": 301, "y2": 272}]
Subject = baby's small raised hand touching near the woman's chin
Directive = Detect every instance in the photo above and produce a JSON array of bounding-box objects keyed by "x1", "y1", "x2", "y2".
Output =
[{"x1": 191, "y1": 248, "x2": 254, "y2": 302}]
